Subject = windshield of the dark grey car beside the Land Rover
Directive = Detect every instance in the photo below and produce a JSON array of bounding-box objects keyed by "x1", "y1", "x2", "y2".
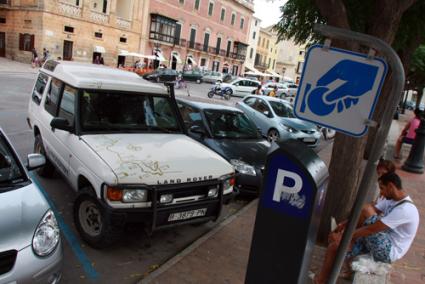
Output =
[{"x1": 204, "y1": 110, "x2": 259, "y2": 139}]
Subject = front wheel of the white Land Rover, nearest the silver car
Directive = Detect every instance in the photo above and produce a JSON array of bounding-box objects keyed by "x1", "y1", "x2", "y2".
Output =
[{"x1": 74, "y1": 188, "x2": 123, "y2": 249}]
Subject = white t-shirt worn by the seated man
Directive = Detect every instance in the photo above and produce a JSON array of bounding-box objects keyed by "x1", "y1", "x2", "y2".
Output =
[{"x1": 375, "y1": 196, "x2": 419, "y2": 262}]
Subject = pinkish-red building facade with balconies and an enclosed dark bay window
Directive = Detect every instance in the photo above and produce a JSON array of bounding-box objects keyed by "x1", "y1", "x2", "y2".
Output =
[{"x1": 141, "y1": 0, "x2": 254, "y2": 75}]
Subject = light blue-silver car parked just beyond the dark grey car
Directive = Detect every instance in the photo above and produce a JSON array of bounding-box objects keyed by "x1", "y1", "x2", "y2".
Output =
[{"x1": 236, "y1": 96, "x2": 320, "y2": 147}]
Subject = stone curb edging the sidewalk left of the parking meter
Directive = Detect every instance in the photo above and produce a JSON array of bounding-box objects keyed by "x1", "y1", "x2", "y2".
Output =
[{"x1": 137, "y1": 198, "x2": 258, "y2": 284}]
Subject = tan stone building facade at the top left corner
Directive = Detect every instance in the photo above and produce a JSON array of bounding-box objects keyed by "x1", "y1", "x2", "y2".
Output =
[{"x1": 0, "y1": 0, "x2": 149, "y2": 66}]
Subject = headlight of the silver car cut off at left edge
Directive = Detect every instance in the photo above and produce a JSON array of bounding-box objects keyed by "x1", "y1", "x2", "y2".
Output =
[{"x1": 32, "y1": 209, "x2": 60, "y2": 256}]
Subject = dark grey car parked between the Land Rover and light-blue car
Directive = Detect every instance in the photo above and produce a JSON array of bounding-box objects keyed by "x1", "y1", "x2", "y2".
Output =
[{"x1": 177, "y1": 99, "x2": 270, "y2": 195}]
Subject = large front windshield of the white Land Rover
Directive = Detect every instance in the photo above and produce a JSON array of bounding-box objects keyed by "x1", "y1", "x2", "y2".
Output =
[{"x1": 80, "y1": 90, "x2": 181, "y2": 133}]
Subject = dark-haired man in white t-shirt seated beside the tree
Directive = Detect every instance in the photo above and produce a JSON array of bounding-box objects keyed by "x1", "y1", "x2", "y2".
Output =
[{"x1": 314, "y1": 172, "x2": 419, "y2": 283}]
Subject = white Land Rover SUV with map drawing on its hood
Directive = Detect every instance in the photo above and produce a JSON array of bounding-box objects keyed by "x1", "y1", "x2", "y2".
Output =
[{"x1": 28, "y1": 60, "x2": 234, "y2": 248}]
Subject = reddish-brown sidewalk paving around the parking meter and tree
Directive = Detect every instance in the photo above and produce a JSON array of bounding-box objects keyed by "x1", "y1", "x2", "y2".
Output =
[{"x1": 141, "y1": 111, "x2": 425, "y2": 284}]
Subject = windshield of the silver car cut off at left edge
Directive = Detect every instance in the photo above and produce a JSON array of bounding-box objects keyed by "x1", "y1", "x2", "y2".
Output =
[{"x1": 0, "y1": 133, "x2": 26, "y2": 186}]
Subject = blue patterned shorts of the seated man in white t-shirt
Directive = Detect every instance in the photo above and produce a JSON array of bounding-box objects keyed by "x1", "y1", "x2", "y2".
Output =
[{"x1": 347, "y1": 215, "x2": 392, "y2": 263}]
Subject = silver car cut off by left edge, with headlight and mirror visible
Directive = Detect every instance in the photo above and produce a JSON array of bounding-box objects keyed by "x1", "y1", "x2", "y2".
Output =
[{"x1": 0, "y1": 128, "x2": 63, "y2": 283}]
